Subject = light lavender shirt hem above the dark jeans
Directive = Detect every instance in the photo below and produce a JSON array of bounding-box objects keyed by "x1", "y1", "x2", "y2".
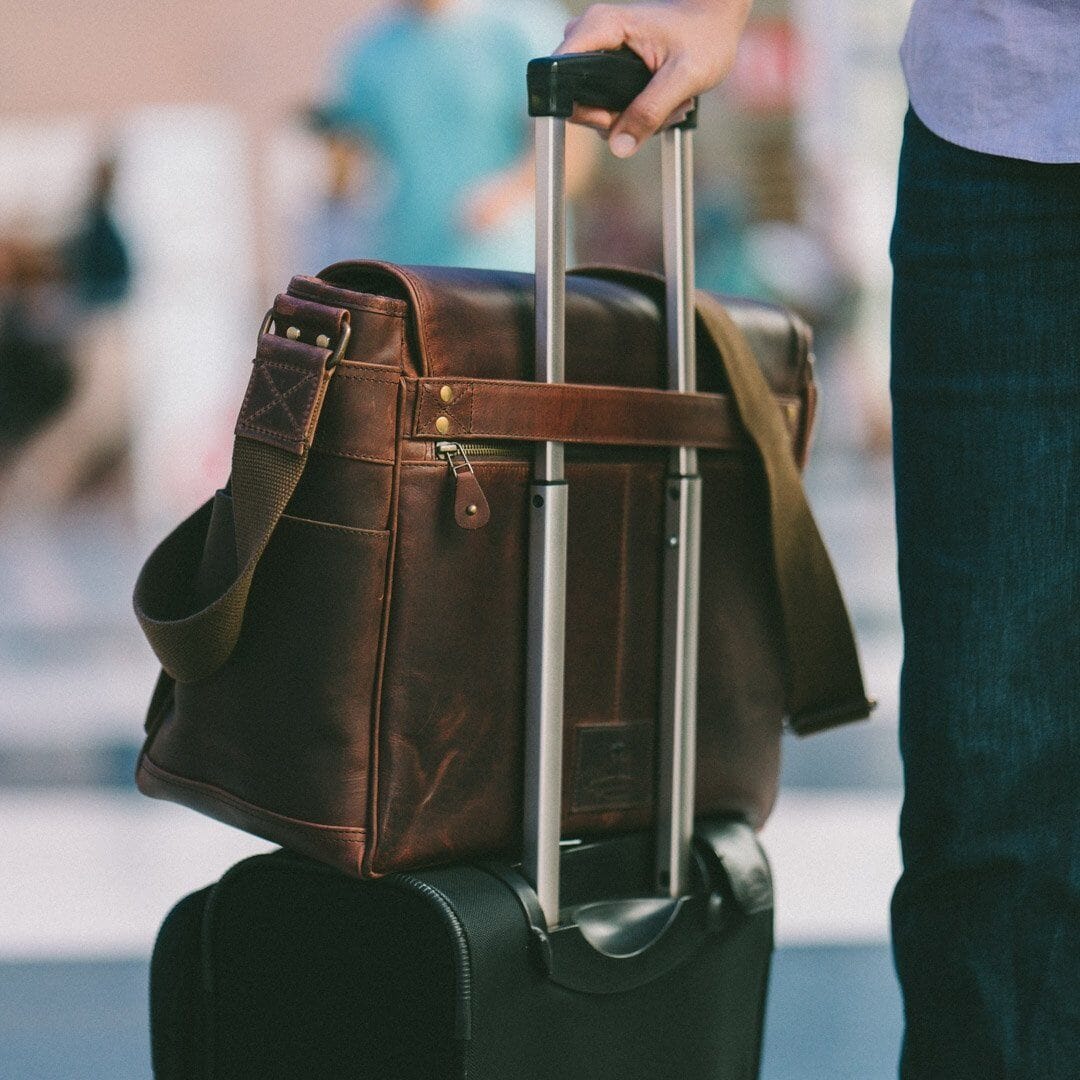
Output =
[{"x1": 901, "y1": 0, "x2": 1080, "y2": 162}]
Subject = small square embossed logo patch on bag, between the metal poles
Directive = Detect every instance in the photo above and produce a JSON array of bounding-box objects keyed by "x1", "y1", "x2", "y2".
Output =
[{"x1": 570, "y1": 720, "x2": 653, "y2": 813}]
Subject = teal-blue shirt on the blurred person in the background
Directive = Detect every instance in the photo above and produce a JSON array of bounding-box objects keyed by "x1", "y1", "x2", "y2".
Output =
[{"x1": 330, "y1": 0, "x2": 566, "y2": 270}]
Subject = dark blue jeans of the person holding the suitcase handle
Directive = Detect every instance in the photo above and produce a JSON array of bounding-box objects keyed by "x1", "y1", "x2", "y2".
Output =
[{"x1": 892, "y1": 105, "x2": 1080, "y2": 1080}]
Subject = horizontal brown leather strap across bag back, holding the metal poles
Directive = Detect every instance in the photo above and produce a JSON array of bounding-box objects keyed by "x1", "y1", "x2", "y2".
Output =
[{"x1": 413, "y1": 378, "x2": 801, "y2": 449}]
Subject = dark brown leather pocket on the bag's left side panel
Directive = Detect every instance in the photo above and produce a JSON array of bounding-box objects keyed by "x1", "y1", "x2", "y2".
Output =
[{"x1": 146, "y1": 491, "x2": 390, "y2": 842}]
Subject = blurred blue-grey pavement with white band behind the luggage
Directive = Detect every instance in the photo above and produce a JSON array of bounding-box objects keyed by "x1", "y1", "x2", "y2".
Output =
[{"x1": 0, "y1": 373, "x2": 901, "y2": 1080}]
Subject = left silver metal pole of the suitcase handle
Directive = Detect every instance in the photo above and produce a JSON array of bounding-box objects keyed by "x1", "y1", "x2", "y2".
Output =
[{"x1": 524, "y1": 117, "x2": 567, "y2": 927}]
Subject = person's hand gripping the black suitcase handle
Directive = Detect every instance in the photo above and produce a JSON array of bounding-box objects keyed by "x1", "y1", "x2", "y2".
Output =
[{"x1": 556, "y1": 0, "x2": 752, "y2": 158}]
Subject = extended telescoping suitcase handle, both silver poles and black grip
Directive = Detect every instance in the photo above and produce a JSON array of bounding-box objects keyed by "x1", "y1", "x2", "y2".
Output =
[{"x1": 524, "y1": 50, "x2": 701, "y2": 928}]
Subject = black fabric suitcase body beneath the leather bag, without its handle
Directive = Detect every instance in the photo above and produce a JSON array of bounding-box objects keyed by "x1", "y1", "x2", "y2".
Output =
[{"x1": 150, "y1": 820, "x2": 772, "y2": 1080}]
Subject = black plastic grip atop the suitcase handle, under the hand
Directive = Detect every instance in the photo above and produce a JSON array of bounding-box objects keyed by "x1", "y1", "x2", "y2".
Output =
[{"x1": 526, "y1": 49, "x2": 697, "y2": 127}]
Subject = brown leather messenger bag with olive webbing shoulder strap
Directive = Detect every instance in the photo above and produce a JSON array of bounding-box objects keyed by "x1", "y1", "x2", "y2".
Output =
[{"x1": 135, "y1": 262, "x2": 869, "y2": 876}]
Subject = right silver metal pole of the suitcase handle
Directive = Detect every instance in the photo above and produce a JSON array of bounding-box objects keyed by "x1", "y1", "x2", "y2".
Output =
[{"x1": 656, "y1": 127, "x2": 701, "y2": 896}]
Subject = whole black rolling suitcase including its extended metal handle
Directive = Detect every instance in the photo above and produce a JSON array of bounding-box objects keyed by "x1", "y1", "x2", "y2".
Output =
[{"x1": 151, "y1": 57, "x2": 772, "y2": 1080}]
